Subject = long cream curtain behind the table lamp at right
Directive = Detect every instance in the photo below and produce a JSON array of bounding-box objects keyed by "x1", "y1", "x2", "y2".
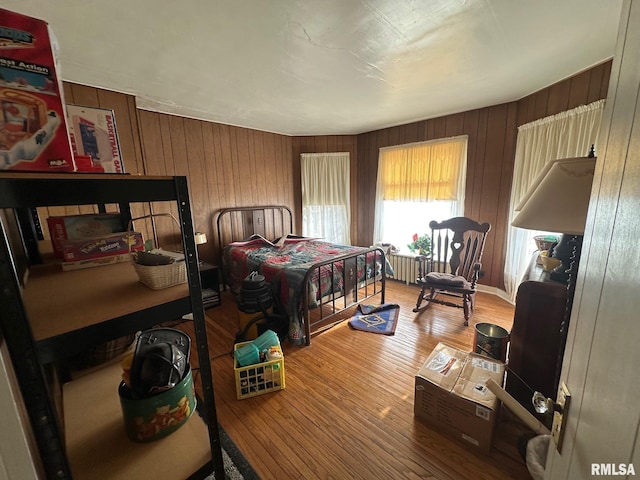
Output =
[{"x1": 504, "y1": 100, "x2": 604, "y2": 302}]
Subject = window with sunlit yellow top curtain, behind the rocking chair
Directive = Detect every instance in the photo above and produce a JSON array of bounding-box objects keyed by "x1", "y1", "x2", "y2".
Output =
[{"x1": 374, "y1": 135, "x2": 467, "y2": 252}]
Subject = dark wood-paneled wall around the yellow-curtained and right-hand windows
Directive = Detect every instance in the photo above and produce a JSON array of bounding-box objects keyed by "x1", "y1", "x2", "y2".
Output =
[{"x1": 357, "y1": 61, "x2": 611, "y2": 288}]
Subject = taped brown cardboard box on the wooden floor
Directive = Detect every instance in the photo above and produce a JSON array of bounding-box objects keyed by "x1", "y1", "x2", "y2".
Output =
[{"x1": 414, "y1": 343, "x2": 505, "y2": 453}]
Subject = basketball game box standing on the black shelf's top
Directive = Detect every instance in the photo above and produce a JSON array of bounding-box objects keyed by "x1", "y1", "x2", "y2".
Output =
[{"x1": 67, "y1": 105, "x2": 124, "y2": 173}]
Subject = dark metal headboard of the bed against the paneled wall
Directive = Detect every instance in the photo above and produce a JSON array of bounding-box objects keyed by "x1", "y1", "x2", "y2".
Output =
[{"x1": 216, "y1": 205, "x2": 293, "y2": 250}]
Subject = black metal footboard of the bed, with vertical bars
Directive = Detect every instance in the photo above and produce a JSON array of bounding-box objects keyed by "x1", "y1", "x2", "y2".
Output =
[{"x1": 302, "y1": 247, "x2": 387, "y2": 345}]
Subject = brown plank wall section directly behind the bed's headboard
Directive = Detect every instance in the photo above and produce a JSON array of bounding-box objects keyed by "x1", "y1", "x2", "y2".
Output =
[{"x1": 138, "y1": 110, "x2": 299, "y2": 263}]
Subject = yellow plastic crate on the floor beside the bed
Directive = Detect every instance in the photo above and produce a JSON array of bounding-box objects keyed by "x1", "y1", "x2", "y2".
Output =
[{"x1": 234, "y1": 342, "x2": 285, "y2": 400}]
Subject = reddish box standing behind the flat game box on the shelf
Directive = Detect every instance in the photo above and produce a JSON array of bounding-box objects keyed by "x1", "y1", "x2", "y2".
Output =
[{"x1": 47, "y1": 213, "x2": 127, "y2": 257}]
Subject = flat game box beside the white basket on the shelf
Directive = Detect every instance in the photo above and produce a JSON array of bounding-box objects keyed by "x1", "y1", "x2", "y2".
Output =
[{"x1": 62, "y1": 232, "x2": 144, "y2": 262}]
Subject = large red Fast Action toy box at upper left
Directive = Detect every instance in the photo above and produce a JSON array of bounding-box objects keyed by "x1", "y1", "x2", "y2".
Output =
[{"x1": 0, "y1": 9, "x2": 75, "y2": 172}]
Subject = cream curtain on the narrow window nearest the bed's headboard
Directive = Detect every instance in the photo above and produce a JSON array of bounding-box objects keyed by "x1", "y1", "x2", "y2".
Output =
[{"x1": 300, "y1": 152, "x2": 351, "y2": 245}]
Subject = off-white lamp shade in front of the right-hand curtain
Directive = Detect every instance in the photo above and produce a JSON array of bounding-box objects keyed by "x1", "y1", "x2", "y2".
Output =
[{"x1": 511, "y1": 157, "x2": 596, "y2": 235}]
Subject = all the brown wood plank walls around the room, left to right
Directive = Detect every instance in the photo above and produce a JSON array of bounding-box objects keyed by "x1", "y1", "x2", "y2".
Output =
[{"x1": 58, "y1": 61, "x2": 611, "y2": 288}]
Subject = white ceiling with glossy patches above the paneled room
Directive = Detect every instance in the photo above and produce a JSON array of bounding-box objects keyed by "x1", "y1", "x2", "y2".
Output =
[{"x1": 0, "y1": 0, "x2": 622, "y2": 135}]
